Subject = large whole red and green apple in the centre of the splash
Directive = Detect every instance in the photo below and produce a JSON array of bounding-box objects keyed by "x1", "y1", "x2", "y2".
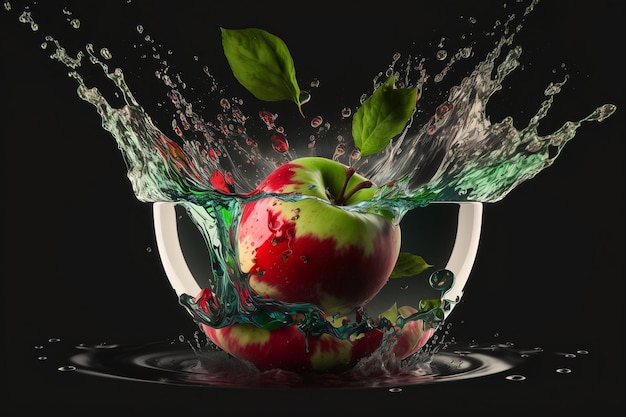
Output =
[{"x1": 237, "y1": 157, "x2": 401, "y2": 317}]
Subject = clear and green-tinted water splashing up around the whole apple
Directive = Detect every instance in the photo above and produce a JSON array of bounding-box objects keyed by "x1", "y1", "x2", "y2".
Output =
[{"x1": 5, "y1": 2, "x2": 616, "y2": 372}]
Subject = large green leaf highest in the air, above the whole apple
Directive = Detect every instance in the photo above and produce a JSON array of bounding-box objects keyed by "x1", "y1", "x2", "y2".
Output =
[{"x1": 220, "y1": 28, "x2": 302, "y2": 114}]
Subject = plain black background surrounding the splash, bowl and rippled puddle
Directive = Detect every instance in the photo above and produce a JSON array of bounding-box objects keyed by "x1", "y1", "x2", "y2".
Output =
[{"x1": 0, "y1": 0, "x2": 626, "y2": 416}]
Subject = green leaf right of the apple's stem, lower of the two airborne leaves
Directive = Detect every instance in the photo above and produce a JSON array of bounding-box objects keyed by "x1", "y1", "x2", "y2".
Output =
[{"x1": 352, "y1": 76, "x2": 417, "y2": 156}]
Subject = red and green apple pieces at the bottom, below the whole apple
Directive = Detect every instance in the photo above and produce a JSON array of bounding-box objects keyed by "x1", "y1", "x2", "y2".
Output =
[{"x1": 200, "y1": 306, "x2": 434, "y2": 372}]
